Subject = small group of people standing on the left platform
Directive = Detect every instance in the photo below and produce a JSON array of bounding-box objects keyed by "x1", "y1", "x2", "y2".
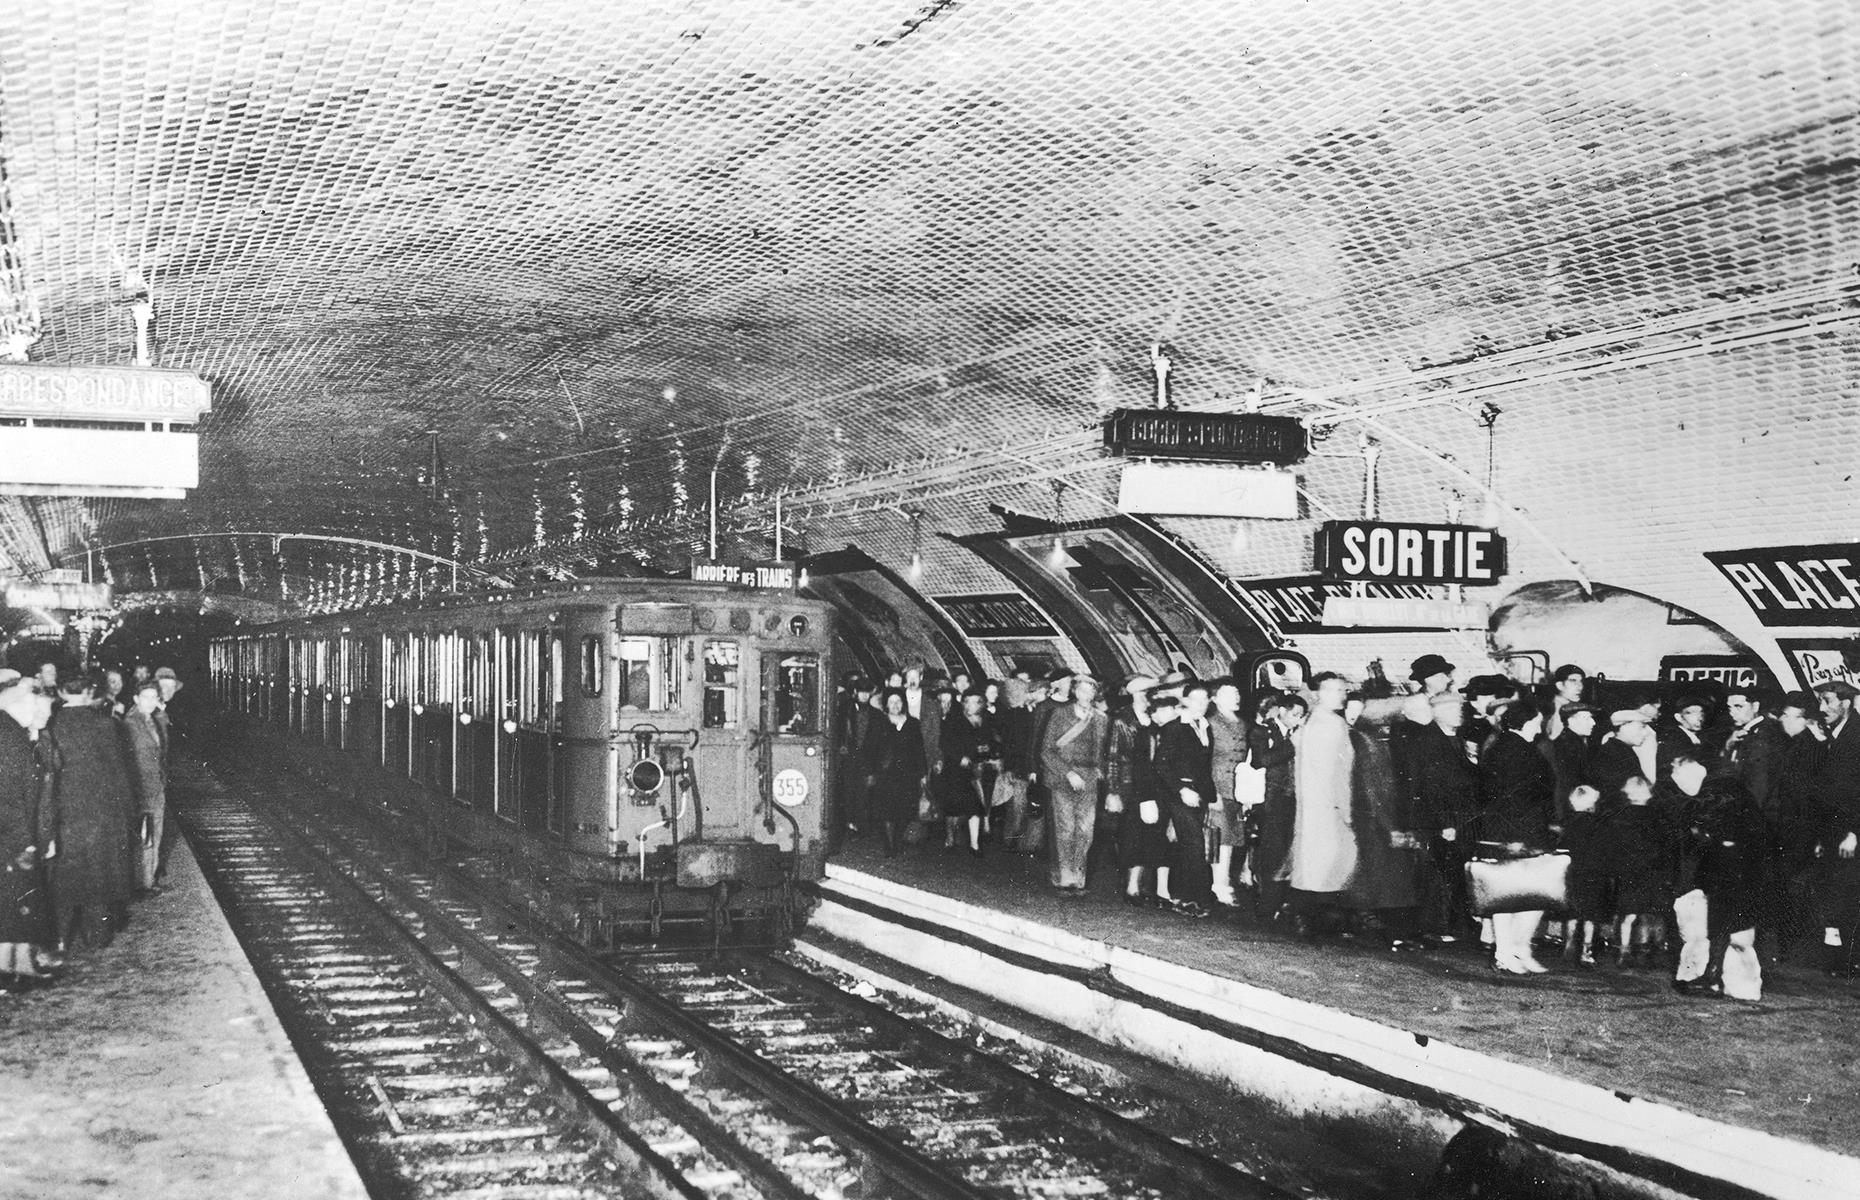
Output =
[{"x1": 0, "y1": 662, "x2": 182, "y2": 992}]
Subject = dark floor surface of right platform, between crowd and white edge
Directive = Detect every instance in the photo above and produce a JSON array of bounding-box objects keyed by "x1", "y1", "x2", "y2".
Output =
[{"x1": 833, "y1": 839, "x2": 1860, "y2": 1153}]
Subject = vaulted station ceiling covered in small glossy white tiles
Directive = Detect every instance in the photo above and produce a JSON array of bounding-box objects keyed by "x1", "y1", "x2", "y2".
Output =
[{"x1": 0, "y1": 0, "x2": 1860, "y2": 669}]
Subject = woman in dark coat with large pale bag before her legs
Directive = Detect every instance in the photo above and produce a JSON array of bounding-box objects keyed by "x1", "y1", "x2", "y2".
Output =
[{"x1": 1479, "y1": 700, "x2": 1557, "y2": 975}]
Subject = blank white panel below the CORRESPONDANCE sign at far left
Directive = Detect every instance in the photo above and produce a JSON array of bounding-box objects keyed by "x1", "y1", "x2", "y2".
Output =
[{"x1": 0, "y1": 426, "x2": 201, "y2": 500}]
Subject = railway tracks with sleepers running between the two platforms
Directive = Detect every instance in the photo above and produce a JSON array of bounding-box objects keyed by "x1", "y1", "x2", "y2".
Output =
[{"x1": 184, "y1": 759, "x2": 1287, "y2": 1200}]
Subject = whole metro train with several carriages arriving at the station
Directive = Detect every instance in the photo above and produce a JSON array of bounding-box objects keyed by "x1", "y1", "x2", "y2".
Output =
[{"x1": 208, "y1": 571, "x2": 833, "y2": 949}]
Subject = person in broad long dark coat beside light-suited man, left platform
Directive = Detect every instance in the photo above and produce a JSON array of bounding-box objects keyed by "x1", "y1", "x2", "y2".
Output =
[{"x1": 52, "y1": 677, "x2": 138, "y2": 945}]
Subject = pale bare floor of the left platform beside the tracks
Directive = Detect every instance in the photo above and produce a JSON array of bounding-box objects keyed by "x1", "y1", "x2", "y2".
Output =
[{"x1": 0, "y1": 839, "x2": 366, "y2": 1200}]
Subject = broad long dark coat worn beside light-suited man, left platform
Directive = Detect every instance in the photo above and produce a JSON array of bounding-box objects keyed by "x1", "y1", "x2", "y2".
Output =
[{"x1": 52, "y1": 705, "x2": 140, "y2": 908}]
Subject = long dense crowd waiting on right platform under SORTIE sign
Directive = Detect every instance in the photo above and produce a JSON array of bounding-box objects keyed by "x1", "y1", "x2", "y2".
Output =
[{"x1": 835, "y1": 655, "x2": 1860, "y2": 999}]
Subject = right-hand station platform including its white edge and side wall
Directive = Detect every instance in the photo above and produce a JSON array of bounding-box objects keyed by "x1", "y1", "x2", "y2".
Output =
[{"x1": 809, "y1": 837, "x2": 1860, "y2": 1196}]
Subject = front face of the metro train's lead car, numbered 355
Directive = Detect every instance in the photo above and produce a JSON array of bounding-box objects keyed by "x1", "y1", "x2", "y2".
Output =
[{"x1": 569, "y1": 586, "x2": 833, "y2": 943}]
